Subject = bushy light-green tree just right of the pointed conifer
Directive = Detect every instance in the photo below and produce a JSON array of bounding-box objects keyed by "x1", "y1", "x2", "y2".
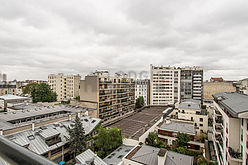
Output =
[{"x1": 93, "y1": 128, "x2": 122, "y2": 158}]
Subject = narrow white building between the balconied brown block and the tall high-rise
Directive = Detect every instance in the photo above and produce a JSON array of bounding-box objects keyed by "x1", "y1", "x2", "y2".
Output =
[{"x1": 135, "y1": 79, "x2": 150, "y2": 105}]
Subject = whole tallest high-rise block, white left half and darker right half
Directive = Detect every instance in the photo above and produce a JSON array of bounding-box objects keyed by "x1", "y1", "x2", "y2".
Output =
[{"x1": 150, "y1": 65, "x2": 203, "y2": 105}]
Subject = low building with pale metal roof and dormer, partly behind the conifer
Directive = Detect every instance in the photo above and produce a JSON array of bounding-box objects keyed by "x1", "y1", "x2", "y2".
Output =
[{"x1": 6, "y1": 116, "x2": 101, "y2": 162}]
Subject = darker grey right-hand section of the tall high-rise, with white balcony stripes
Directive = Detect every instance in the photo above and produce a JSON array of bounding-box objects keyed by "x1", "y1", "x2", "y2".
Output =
[{"x1": 180, "y1": 66, "x2": 203, "y2": 101}]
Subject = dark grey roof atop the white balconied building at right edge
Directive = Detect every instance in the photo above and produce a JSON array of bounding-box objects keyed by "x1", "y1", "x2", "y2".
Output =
[{"x1": 213, "y1": 92, "x2": 248, "y2": 117}]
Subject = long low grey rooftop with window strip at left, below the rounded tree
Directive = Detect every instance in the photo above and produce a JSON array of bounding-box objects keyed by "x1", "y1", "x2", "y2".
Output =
[{"x1": 0, "y1": 103, "x2": 93, "y2": 130}]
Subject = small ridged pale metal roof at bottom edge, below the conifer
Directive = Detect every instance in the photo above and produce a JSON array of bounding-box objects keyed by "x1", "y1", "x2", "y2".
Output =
[{"x1": 76, "y1": 149, "x2": 107, "y2": 165}]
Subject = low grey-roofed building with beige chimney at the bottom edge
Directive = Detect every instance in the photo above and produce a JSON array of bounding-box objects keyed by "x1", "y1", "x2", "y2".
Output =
[{"x1": 123, "y1": 145, "x2": 194, "y2": 165}]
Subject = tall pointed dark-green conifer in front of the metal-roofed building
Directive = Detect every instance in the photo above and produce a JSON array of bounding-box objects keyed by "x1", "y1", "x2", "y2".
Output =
[{"x1": 68, "y1": 116, "x2": 86, "y2": 158}]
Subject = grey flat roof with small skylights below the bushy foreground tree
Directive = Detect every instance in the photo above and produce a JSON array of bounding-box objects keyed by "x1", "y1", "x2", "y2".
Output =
[{"x1": 103, "y1": 145, "x2": 134, "y2": 165}]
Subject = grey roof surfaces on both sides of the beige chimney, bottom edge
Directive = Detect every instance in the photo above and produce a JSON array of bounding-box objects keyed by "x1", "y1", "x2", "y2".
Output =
[{"x1": 127, "y1": 145, "x2": 194, "y2": 165}]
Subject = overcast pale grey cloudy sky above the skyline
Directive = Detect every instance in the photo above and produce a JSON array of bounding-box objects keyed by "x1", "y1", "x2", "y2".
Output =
[{"x1": 0, "y1": 0, "x2": 248, "y2": 80}]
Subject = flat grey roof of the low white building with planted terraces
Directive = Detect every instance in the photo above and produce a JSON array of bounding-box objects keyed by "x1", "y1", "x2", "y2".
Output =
[{"x1": 159, "y1": 120, "x2": 196, "y2": 135}]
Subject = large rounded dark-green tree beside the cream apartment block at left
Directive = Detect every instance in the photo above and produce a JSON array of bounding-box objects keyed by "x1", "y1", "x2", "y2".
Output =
[{"x1": 31, "y1": 83, "x2": 57, "y2": 103}]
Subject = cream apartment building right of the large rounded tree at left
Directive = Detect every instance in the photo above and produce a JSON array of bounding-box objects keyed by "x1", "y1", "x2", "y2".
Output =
[{"x1": 48, "y1": 73, "x2": 81, "y2": 101}]
